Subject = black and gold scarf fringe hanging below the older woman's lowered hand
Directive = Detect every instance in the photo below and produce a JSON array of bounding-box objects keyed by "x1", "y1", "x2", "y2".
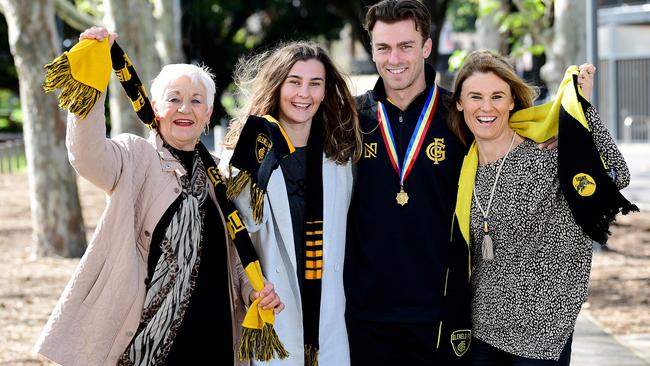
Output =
[{"x1": 238, "y1": 323, "x2": 289, "y2": 361}]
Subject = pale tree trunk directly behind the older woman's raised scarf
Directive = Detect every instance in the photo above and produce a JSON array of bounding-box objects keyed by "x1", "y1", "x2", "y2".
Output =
[{"x1": 104, "y1": 0, "x2": 160, "y2": 136}]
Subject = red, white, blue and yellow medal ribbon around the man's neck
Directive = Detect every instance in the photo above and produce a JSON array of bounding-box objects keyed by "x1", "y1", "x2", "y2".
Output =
[{"x1": 377, "y1": 84, "x2": 438, "y2": 186}]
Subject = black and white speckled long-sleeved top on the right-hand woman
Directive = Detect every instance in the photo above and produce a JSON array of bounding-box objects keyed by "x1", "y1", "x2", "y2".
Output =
[{"x1": 470, "y1": 108, "x2": 630, "y2": 360}]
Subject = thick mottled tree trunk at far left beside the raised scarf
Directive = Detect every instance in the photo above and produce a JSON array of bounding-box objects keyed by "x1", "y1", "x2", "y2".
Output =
[{"x1": 0, "y1": 0, "x2": 86, "y2": 257}]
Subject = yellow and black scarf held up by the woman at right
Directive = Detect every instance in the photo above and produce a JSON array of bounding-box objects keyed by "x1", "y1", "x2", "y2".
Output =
[{"x1": 455, "y1": 66, "x2": 638, "y2": 247}]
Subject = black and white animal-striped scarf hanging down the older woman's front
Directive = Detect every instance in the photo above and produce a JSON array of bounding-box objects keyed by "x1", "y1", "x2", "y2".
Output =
[{"x1": 119, "y1": 149, "x2": 208, "y2": 366}]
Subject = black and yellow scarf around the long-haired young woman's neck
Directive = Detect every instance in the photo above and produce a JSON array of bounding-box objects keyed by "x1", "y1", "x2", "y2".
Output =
[{"x1": 228, "y1": 115, "x2": 323, "y2": 366}]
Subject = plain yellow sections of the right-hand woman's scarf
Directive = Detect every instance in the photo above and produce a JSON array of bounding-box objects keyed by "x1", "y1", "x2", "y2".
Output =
[{"x1": 455, "y1": 66, "x2": 588, "y2": 245}]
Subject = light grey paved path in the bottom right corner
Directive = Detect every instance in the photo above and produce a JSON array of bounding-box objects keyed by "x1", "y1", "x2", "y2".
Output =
[{"x1": 571, "y1": 314, "x2": 650, "y2": 366}]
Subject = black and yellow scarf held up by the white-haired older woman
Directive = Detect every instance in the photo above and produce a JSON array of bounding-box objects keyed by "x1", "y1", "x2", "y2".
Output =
[{"x1": 44, "y1": 40, "x2": 288, "y2": 361}]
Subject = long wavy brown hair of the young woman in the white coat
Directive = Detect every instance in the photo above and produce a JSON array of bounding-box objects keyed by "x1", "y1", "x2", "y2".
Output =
[{"x1": 224, "y1": 41, "x2": 362, "y2": 164}]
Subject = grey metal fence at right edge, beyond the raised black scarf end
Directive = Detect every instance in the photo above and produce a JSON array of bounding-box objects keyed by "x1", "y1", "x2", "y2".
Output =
[{"x1": 598, "y1": 57, "x2": 650, "y2": 143}]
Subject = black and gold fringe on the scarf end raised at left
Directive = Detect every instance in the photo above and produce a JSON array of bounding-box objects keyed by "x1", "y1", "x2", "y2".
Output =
[{"x1": 43, "y1": 54, "x2": 101, "y2": 118}]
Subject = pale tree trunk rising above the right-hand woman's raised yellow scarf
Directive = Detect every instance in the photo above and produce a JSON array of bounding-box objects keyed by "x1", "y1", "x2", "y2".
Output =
[{"x1": 541, "y1": 0, "x2": 587, "y2": 93}]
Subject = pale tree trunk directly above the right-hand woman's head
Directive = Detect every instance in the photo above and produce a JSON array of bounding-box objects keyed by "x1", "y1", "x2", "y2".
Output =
[{"x1": 476, "y1": 0, "x2": 510, "y2": 55}]
